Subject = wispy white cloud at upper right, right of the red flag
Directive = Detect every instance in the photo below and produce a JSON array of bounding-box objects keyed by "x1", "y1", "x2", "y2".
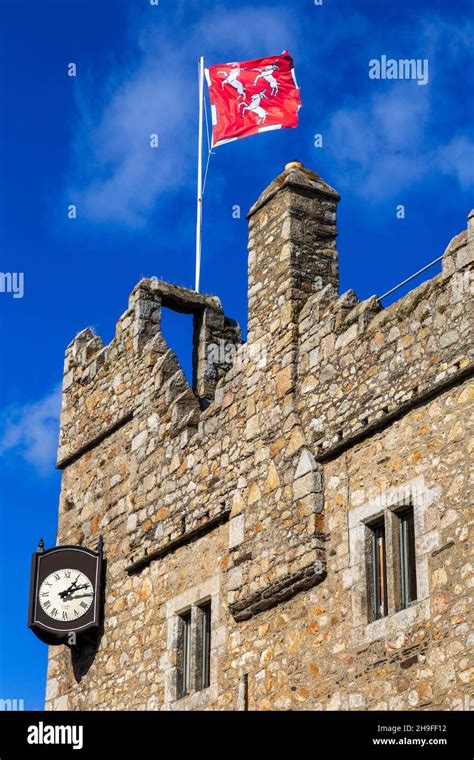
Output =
[{"x1": 325, "y1": 14, "x2": 474, "y2": 202}]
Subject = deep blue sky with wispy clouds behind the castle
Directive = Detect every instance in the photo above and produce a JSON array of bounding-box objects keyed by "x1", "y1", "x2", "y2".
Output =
[{"x1": 0, "y1": 0, "x2": 474, "y2": 709}]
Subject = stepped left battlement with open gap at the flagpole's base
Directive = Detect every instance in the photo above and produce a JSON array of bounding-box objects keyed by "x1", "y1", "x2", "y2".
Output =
[{"x1": 58, "y1": 279, "x2": 241, "y2": 467}]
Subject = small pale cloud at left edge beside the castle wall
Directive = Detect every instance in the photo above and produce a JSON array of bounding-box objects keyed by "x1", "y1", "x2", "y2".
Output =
[{"x1": 0, "y1": 388, "x2": 61, "y2": 474}]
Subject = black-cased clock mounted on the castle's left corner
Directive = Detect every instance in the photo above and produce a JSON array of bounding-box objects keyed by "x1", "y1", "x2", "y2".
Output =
[{"x1": 28, "y1": 538, "x2": 103, "y2": 644}]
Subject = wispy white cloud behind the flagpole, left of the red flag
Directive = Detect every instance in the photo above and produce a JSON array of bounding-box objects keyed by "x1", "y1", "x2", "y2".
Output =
[{"x1": 67, "y1": 7, "x2": 295, "y2": 227}]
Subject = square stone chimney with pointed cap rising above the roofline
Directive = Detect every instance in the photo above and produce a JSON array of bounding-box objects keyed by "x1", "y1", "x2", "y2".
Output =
[{"x1": 247, "y1": 161, "x2": 340, "y2": 342}]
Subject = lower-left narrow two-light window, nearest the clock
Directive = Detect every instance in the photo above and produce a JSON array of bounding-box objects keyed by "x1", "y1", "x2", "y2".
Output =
[{"x1": 177, "y1": 602, "x2": 211, "y2": 699}]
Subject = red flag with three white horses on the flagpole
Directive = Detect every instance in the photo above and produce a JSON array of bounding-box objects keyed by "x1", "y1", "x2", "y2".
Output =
[{"x1": 206, "y1": 50, "x2": 301, "y2": 147}]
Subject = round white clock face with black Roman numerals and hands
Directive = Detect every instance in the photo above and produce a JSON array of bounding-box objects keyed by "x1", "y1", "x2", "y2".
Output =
[{"x1": 39, "y1": 568, "x2": 94, "y2": 622}]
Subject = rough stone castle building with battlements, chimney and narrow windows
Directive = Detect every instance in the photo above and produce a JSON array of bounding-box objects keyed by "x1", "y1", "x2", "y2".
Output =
[{"x1": 46, "y1": 162, "x2": 474, "y2": 710}]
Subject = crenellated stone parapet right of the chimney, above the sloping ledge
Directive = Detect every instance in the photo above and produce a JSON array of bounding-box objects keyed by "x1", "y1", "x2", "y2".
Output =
[{"x1": 299, "y1": 226, "x2": 473, "y2": 454}]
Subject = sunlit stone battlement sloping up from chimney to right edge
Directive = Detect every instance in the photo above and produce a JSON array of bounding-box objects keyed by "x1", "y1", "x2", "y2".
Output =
[{"x1": 298, "y1": 212, "x2": 474, "y2": 458}]
